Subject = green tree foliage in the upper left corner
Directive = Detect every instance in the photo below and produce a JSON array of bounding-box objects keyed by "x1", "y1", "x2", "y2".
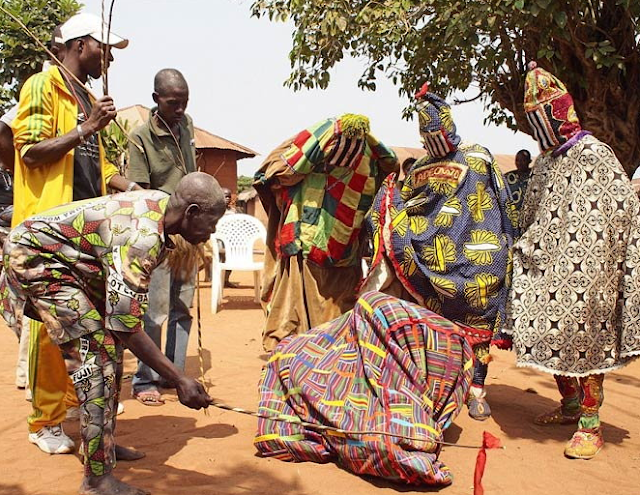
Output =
[{"x1": 0, "y1": 0, "x2": 82, "y2": 114}]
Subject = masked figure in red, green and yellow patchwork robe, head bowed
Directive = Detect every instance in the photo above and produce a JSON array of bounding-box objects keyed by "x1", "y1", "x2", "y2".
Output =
[{"x1": 254, "y1": 114, "x2": 397, "y2": 350}]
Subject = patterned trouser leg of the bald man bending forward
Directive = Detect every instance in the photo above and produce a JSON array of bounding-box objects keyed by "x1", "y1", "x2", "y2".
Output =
[{"x1": 60, "y1": 330, "x2": 123, "y2": 476}]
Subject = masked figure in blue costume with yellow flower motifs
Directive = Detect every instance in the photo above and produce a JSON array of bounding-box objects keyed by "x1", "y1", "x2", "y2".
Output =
[{"x1": 363, "y1": 85, "x2": 516, "y2": 419}]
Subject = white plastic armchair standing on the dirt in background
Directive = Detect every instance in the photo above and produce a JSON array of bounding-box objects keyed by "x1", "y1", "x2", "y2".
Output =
[{"x1": 211, "y1": 213, "x2": 267, "y2": 313}]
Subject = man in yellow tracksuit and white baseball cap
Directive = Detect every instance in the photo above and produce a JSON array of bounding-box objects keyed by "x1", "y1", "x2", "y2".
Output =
[{"x1": 12, "y1": 9, "x2": 139, "y2": 476}]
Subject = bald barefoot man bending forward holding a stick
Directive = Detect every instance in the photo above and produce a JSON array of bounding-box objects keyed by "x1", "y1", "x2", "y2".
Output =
[{"x1": 0, "y1": 172, "x2": 225, "y2": 495}]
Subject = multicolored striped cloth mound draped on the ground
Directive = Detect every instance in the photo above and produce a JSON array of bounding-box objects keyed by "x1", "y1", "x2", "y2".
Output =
[{"x1": 254, "y1": 292, "x2": 473, "y2": 485}]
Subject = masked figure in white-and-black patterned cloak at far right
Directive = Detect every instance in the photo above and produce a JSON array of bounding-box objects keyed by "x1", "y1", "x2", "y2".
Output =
[{"x1": 506, "y1": 63, "x2": 640, "y2": 459}]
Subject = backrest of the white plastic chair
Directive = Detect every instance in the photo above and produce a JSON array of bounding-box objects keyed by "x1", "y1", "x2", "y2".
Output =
[{"x1": 214, "y1": 213, "x2": 267, "y2": 266}]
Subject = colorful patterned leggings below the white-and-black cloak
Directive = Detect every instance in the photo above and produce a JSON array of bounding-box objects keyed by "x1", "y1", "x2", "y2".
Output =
[{"x1": 554, "y1": 374, "x2": 604, "y2": 429}]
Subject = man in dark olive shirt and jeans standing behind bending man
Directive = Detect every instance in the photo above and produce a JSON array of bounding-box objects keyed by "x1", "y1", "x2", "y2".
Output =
[{"x1": 127, "y1": 69, "x2": 197, "y2": 406}]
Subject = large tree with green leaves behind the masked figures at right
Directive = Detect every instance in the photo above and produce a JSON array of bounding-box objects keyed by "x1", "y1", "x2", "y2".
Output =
[{"x1": 252, "y1": 0, "x2": 640, "y2": 171}]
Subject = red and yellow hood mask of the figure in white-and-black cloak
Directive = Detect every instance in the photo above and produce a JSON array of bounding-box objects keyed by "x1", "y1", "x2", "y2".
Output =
[{"x1": 524, "y1": 62, "x2": 582, "y2": 151}]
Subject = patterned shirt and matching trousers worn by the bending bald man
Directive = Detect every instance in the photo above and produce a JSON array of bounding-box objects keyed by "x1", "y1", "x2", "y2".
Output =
[{"x1": 0, "y1": 191, "x2": 169, "y2": 476}]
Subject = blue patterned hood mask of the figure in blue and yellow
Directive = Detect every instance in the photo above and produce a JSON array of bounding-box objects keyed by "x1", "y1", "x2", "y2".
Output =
[{"x1": 415, "y1": 83, "x2": 460, "y2": 158}]
